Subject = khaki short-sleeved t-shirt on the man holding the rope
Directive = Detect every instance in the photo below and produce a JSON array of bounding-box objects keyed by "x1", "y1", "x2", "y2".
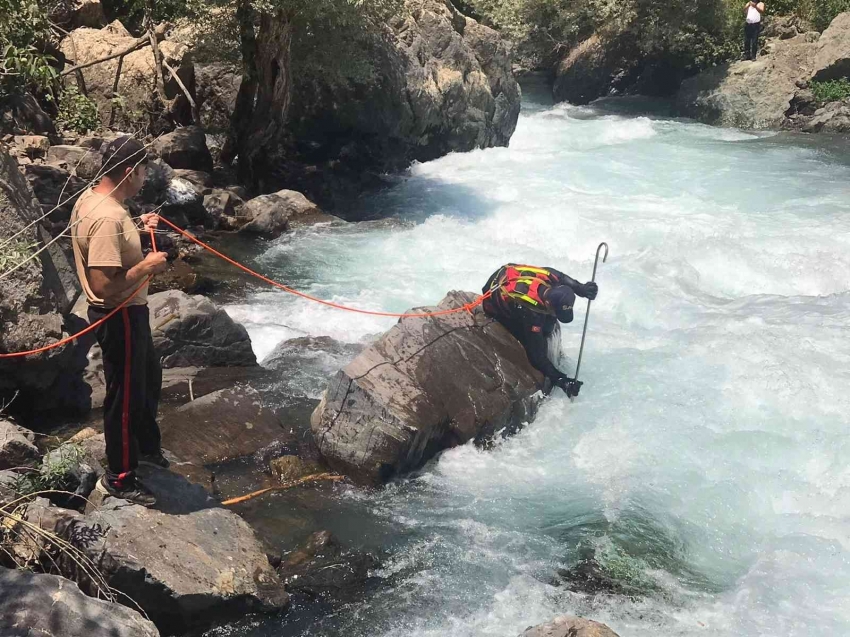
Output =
[{"x1": 71, "y1": 189, "x2": 148, "y2": 308}]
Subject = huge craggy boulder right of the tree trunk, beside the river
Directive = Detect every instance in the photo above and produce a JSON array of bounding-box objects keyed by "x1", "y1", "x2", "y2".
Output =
[{"x1": 289, "y1": 0, "x2": 521, "y2": 172}]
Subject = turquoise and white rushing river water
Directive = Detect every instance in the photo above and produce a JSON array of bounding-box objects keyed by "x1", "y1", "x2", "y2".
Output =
[{"x1": 216, "y1": 85, "x2": 850, "y2": 637}]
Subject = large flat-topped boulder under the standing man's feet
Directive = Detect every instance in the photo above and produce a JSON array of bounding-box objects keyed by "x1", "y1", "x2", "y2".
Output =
[{"x1": 26, "y1": 469, "x2": 289, "y2": 635}]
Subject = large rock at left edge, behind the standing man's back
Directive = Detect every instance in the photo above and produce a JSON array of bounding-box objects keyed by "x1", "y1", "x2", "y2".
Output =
[{"x1": 0, "y1": 146, "x2": 86, "y2": 412}]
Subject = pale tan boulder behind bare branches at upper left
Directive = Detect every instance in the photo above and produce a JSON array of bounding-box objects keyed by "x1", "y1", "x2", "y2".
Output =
[{"x1": 60, "y1": 23, "x2": 195, "y2": 130}]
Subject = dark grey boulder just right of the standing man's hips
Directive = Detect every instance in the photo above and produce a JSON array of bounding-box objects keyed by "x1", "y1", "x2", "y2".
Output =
[{"x1": 148, "y1": 290, "x2": 257, "y2": 367}]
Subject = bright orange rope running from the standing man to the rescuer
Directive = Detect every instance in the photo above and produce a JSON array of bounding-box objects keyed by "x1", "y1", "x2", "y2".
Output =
[{"x1": 0, "y1": 217, "x2": 493, "y2": 359}]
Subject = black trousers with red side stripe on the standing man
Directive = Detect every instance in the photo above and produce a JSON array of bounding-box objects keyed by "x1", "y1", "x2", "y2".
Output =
[{"x1": 89, "y1": 305, "x2": 162, "y2": 487}]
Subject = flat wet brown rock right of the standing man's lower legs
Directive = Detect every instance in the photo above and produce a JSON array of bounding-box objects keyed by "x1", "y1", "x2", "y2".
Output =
[{"x1": 160, "y1": 385, "x2": 284, "y2": 464}]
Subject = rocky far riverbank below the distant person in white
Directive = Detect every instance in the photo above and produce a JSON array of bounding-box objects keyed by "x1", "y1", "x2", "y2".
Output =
[{"x1": 553, "y1": 13, "x2": 850, "y2": 134}]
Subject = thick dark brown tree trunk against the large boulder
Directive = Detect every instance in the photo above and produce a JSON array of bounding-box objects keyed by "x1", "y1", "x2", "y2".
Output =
[{"x1": 222, "y1": 0, "x2": 292, "y2": 190}]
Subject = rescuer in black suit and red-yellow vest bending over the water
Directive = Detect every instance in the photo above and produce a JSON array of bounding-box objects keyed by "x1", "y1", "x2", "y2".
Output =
[{"x1": 482, "y1": 263, "x2": 599, "y2": 398}]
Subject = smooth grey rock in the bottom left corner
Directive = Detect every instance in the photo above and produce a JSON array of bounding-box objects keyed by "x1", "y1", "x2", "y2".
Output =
[{"x1": 0, "y1": 568, "x2": 159, "y2": 637}]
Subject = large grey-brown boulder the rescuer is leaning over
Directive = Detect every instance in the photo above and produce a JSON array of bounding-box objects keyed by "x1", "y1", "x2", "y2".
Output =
[{"x1": 311, "y1": 292, "x2": 544, "y2": 483}]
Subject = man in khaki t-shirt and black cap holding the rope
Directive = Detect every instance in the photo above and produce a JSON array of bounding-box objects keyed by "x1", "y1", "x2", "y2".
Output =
[{"x1": 71, "y1": 136, "x2": 168, "y2": 507}]
